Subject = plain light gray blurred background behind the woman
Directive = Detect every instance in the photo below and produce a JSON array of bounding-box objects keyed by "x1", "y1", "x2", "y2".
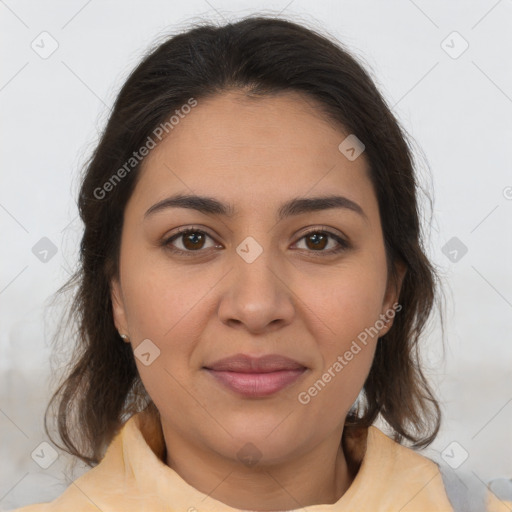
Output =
[{"x1": 0, "y1": 0, "x2": 512, "y2": 510}]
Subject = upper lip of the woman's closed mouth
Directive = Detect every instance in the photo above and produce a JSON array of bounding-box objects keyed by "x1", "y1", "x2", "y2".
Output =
[{"x1": 205, "y1": 354, "x2": 305, "y2": 373}]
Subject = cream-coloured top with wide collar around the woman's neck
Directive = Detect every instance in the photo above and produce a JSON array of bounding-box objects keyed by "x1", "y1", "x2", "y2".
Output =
[{"x1": 11, "y1": 411, "x2": 460, "y2": 512}]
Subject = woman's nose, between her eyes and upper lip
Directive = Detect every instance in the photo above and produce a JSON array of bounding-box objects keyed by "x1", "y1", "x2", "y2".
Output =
[{"x1": 218, "y1": 245, "x2": 295, "y2": 334}]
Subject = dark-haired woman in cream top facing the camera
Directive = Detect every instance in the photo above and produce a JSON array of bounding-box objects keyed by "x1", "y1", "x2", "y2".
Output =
[{"x1": 13, "y1": 17, "x2": 464, "y2": 512}]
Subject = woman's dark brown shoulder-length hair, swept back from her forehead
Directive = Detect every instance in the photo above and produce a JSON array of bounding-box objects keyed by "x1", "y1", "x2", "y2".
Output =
[{"x1": 45, "y1": 16, "x2": 441, "y2": 466}]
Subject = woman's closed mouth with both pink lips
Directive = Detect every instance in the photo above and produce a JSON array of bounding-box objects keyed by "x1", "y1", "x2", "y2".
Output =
[{"x1": 203, "y1": 354, "x2": 307, "y2": 398}]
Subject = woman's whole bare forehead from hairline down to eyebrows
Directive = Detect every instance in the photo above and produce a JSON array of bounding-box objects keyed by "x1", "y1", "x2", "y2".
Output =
[{"x1": 126, "y1": 91, "x2": 375, "y2": 220}]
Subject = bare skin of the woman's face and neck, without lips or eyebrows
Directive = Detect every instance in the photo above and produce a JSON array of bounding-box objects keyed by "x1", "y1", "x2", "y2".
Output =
[{"x1": 111, "y1": 91, "x2": 404, "y2": 510}]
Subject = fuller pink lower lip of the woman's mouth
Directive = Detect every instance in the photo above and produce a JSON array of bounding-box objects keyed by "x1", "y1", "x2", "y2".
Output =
[{"x1": 206, "y1": 368, "x2": 306, "y2": 398}]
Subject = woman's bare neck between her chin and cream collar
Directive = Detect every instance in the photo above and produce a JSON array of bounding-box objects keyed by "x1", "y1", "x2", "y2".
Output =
[{"x1": 164, "y1": 428, "x2": 355, "y2": 511}]
